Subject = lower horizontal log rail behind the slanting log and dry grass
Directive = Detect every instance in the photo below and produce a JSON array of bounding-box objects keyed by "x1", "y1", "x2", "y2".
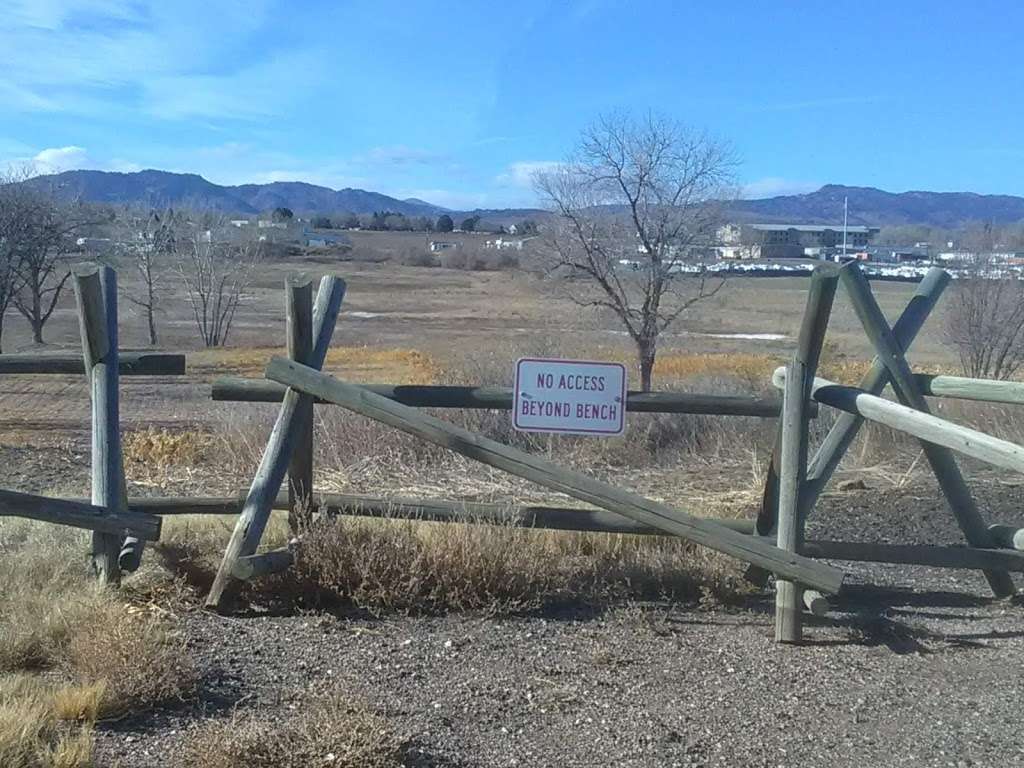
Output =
[{"x1": 121, "y1": 493, "x2": 754, "y2": 536}]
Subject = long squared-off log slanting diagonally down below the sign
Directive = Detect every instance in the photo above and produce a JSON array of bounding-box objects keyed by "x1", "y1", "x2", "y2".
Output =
[{"x1": 267, "y1": 357, "x2": 843, "y2": 593}]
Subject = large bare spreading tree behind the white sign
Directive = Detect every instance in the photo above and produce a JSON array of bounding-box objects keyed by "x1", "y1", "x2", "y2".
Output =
[{"x1": 535, "y1": 114, "x2": 735, "y2": 391}]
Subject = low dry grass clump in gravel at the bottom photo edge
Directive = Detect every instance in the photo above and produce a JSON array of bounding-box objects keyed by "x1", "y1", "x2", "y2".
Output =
[{"x1": 181, "y1": 694, "x2": 407, "y2": 768}]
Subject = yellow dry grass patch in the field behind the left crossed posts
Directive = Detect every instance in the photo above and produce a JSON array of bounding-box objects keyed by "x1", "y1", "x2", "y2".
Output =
[{"x1": 188, "y1": 346, "x2": 441, "y2": 384}]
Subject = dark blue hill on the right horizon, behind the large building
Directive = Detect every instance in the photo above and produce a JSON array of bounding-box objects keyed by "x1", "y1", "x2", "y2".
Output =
[{"x1": 731, "y1": 184, "x2": 1024, "y2": 228}]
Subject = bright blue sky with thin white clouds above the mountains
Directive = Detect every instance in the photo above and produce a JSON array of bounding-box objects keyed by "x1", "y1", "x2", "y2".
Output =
[{"x1": 0, "y1": 0, "x2": 1024, "y2": 208}]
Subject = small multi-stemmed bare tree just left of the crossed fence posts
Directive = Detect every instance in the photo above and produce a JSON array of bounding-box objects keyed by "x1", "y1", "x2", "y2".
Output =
[{"x1": 175, "y1": 217, "x2": 263, "y2": 347}]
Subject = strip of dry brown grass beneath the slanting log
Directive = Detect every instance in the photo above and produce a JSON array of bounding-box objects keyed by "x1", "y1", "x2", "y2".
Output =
[{"x1": 294, "y1": 519, "x2": 744, "y2": 614}]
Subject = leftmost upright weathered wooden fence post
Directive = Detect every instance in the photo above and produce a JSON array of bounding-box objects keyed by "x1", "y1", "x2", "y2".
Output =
[{"x1": 74, "y1": 264, "x2": 129, "y2": 585}]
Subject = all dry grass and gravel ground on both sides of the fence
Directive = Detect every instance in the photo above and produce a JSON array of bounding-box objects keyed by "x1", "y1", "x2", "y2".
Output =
[{"x1": 0, "y1": 257, "x2": 1024, "y2": 768}]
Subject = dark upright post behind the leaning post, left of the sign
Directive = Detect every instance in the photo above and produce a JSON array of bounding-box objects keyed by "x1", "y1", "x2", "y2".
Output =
[{"x1": 285, "y1": 274, "x2": 313, "y2": 534}]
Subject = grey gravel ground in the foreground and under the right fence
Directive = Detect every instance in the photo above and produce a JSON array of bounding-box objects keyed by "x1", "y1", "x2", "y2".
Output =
[{"x1": 81, "y1": 477, "x2": 1024, "y2": 768}]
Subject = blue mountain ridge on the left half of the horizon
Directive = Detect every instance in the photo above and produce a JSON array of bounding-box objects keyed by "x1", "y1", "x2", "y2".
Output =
[{"x1": 26, "y1": 170, "x2": 445, "y2": 216}]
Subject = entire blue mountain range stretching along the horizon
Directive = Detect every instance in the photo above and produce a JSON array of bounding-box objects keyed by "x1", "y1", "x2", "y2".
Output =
[{"x1": 19, "y1": 170, "x2": 1024, "y2": 228}]
